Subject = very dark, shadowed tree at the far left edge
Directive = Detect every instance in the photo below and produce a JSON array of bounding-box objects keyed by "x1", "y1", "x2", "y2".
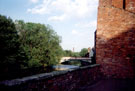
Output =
[{"x1": 0, "y1": 15, "x2": 24, "y2": 72}]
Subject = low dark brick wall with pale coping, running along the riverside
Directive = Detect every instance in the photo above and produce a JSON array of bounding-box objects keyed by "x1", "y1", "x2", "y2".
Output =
[{"x1": 0, "y1": 64, "x2": 102, "y2": 91}]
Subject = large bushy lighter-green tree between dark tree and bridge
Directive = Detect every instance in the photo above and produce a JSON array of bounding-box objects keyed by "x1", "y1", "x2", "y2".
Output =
[{"x1": 15, "y1": 20, "x2": 62, "y2": 67}]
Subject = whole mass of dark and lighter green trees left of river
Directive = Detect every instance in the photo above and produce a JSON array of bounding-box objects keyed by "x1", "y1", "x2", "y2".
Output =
[{"x1": 0, "y1": 15, "x2": 63, "y2": 80}]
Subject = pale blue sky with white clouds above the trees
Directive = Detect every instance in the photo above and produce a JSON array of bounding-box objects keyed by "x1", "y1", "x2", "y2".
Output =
[{"x1": 0, "y1": 0, "x2": 98, "y2": 52}]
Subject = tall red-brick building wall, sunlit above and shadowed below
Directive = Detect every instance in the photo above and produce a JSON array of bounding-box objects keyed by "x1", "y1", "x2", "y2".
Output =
[{"x1": 96, "y1": 0, "x2": 135, "y2": 78}]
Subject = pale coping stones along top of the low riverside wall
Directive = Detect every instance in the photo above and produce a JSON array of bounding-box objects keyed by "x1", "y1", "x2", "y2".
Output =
[{"x1": 0, "y1": 64, "x2": 100, "y2": 86}]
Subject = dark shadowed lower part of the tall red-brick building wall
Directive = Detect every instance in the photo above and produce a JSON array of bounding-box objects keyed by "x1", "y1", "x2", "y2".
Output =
[{"x1": 96, "y1": 27, "x2": 135, "y2": 78}]
